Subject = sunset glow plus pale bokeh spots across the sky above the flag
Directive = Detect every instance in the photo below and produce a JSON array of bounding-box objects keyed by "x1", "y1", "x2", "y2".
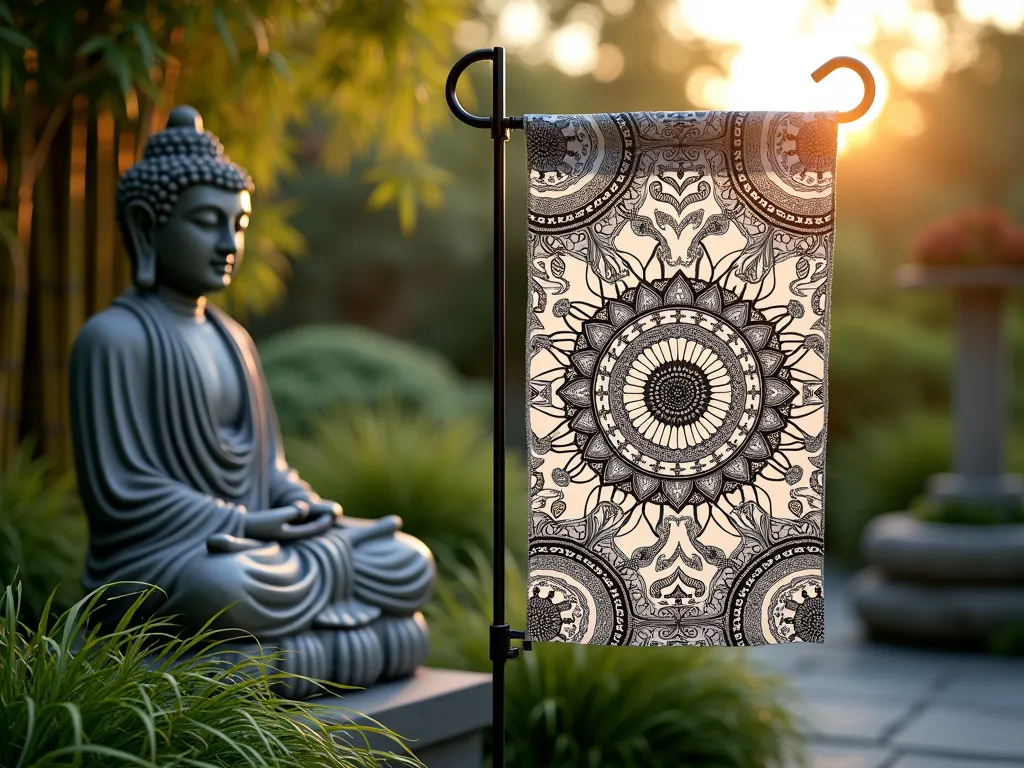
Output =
[{"x1": 464, "y1": 0, "x2": 1024, "y2": 148}]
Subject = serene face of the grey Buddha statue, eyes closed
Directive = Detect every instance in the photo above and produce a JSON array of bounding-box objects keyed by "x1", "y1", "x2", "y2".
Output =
[{"x1": 153, "y1": 185, "x2": 252, "y2": 297}]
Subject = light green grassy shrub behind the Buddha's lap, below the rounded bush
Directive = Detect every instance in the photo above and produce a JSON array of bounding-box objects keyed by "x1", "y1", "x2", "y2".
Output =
[{"x1": 287, "y1": 408, "x2": 526, "y2": 568}]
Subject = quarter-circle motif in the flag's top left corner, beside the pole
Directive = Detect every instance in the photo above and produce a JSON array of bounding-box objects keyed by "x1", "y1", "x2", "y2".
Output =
[{"x1": 525, "y1": 115, "x2": 637, "y2": 233}]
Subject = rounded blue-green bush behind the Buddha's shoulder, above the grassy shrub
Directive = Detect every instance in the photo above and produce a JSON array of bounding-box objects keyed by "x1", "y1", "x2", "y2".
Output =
[{"x1": 260, "y1": 326, "x2": 490, "y2": 435}]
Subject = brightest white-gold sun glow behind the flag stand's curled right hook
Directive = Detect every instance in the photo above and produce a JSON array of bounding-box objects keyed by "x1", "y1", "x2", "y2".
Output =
[{"x1": 663, "y1": 0, "x2": 1024, "y2": 150}]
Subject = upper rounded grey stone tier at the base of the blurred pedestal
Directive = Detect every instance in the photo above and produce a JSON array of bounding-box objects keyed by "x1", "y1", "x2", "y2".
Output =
[{"x1": 863, "y1": 512, "x2": 1024, "y2": 585}]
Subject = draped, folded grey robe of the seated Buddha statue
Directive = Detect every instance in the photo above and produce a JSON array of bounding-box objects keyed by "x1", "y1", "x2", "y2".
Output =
[{"x1": 71, "y1": 289, "x2": 434, "y2": 638}]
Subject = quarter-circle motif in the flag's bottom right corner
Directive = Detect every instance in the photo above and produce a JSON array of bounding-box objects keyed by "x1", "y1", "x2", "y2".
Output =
[{"x1": 726, "y1": 538, "x2": 824, "y2": 645}]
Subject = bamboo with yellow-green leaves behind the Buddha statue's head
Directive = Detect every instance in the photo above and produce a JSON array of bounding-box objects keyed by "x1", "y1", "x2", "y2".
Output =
[{"x1": 0, "y1": 0, "x2": 466, "y2": 469}]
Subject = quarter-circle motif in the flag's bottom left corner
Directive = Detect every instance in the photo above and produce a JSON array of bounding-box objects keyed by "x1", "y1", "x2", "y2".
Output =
[{"x1": 526, "y1": 539, "x2": 632, "y2": 645}]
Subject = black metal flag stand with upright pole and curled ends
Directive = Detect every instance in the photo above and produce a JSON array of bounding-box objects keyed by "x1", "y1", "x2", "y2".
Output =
[{"x1": 444, "y1": 47, "x2": 874, "y2": 768}]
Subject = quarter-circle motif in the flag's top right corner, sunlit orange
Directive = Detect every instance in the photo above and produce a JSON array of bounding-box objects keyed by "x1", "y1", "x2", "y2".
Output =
[{"x1": 726, "y1": 112, "x2": 837, "y2": 234}]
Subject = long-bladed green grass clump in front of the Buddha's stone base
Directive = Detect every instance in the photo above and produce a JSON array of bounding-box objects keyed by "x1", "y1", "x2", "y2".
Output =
[{"x1": 0, "y1": 587, "x2": 412, "y2": 768}]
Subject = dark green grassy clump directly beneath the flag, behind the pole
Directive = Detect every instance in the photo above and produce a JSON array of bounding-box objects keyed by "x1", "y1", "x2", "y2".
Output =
[{"x1": 428, "y1": 553, "x2": 799, "y2": 768}]
